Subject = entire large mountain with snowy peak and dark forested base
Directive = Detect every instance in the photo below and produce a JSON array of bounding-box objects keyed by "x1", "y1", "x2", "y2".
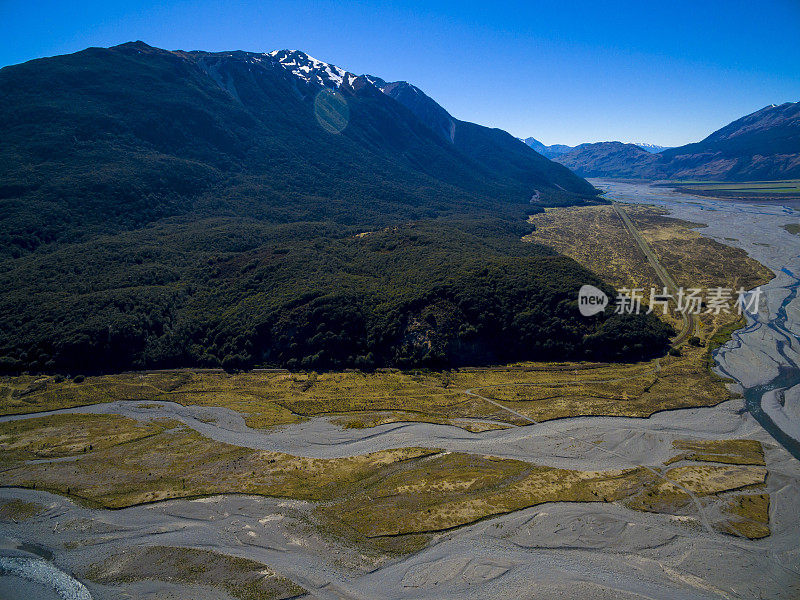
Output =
[{"x1": 0, "y1": 42, "x2": 668, "y2": 374}]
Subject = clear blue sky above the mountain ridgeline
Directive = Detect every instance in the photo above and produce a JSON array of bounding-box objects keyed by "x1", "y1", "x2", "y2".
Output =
[{"x1": 0, "y1": 0, "x2": 800, "y2": 145}]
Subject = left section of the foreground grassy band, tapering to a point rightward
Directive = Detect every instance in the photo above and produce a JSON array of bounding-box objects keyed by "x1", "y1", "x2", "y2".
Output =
[{"x1": 0, "y1": 415, "x2": 438, "y2": 508}]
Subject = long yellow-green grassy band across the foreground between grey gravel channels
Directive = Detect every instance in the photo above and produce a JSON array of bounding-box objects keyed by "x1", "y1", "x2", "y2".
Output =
[{"x1": 0, "y1": 415, "x2": 767, "y2": 552}]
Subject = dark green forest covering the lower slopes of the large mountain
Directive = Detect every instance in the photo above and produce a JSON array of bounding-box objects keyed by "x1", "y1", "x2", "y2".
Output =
[{"x1": 7, "y1": 211, "x2": 680, "y2": 373}]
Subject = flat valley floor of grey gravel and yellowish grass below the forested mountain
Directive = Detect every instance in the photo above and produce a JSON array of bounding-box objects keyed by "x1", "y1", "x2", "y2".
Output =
[{"x1": 0, "y1": 183, "x2": 800, "y2": 600}]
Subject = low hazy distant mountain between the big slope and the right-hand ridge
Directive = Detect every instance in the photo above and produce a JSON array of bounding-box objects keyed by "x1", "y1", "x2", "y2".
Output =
[{"x1": 554, "y1": 142, "x2": 658, "y2": 179}]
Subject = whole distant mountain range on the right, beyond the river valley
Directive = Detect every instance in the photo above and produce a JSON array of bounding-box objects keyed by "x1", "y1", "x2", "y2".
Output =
[{"x1": 554, "y1": 102, "x2": 800, "y2": 181}]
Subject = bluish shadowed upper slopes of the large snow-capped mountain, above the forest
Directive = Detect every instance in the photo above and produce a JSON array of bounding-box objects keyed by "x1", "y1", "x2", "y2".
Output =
[{"x1": 0, "y1": 43, "x2": 595, "y2": 250}]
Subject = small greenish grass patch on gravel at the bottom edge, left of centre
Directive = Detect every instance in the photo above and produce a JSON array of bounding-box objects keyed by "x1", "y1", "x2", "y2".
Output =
[{"x1": 84, "y1": 546, "x2": 306, "y2": 600}]
